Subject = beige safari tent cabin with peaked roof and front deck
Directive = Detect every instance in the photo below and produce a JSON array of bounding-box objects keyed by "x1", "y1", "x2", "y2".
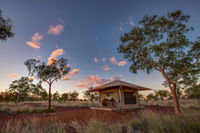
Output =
[{"x1": 88, "y1": 80, "x2": 151, "y2": 111}]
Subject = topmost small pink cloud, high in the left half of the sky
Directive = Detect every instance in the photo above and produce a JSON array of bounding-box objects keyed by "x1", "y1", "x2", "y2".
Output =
[{"x1": 47, "y1": 24, "x2": 64, "y2": 35}]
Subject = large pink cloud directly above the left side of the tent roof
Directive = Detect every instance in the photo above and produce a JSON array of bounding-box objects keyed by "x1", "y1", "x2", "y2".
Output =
[{"x1": 75, "y1": 75, "x2": 123, "y2": 88}]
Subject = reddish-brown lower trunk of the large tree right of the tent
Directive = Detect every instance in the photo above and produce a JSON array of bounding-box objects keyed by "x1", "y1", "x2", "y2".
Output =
[{"x1": 171, "y1": 84, "x2": 181, "y2": 114}]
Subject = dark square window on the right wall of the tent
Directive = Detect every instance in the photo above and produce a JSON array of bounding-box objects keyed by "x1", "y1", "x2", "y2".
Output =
[{"x1": 124, "y1": 92, "x2": 137, "y2": 104}]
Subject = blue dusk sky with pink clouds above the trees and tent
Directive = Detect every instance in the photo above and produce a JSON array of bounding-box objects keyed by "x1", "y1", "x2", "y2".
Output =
[{"x1": 0, "y1": 0, "x2": 200, "y2": 96}]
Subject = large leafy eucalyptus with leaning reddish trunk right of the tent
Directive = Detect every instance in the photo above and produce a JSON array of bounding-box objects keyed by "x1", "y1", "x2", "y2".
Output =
[{"x1": 118, "y1": 10, "x2": 200, "y2": 113}]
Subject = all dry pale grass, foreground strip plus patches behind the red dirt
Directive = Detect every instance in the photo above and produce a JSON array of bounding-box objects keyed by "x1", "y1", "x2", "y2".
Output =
[{"x1": 0, "y1": 100, "x2": 200, "y2": 133}]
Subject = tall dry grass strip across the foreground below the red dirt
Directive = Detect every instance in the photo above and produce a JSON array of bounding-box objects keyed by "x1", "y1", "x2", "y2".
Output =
[{"x1": 0, "y1": 109, "x2": 200, "y2": 133}]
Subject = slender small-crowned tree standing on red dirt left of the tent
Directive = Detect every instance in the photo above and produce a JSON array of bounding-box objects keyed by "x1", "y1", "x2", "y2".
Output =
[{"x1": 24, "y1": 58, "x2": 70, "y2": 109}]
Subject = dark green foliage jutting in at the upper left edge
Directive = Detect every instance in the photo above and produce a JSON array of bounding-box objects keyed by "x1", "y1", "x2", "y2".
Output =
[{"x1": 0, "y1": 10, "x2": 14, "y2": 41}]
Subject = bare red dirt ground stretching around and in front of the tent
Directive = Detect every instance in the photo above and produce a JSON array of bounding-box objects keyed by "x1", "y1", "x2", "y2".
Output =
[{"x1": 0, "y1": 105, "x2": 174, "y2": 125}]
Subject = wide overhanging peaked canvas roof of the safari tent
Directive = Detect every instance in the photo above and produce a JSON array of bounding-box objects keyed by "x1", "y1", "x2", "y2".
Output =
[{"x1": 88, "y1": 80, "x2": 151, "y2": 92}]
